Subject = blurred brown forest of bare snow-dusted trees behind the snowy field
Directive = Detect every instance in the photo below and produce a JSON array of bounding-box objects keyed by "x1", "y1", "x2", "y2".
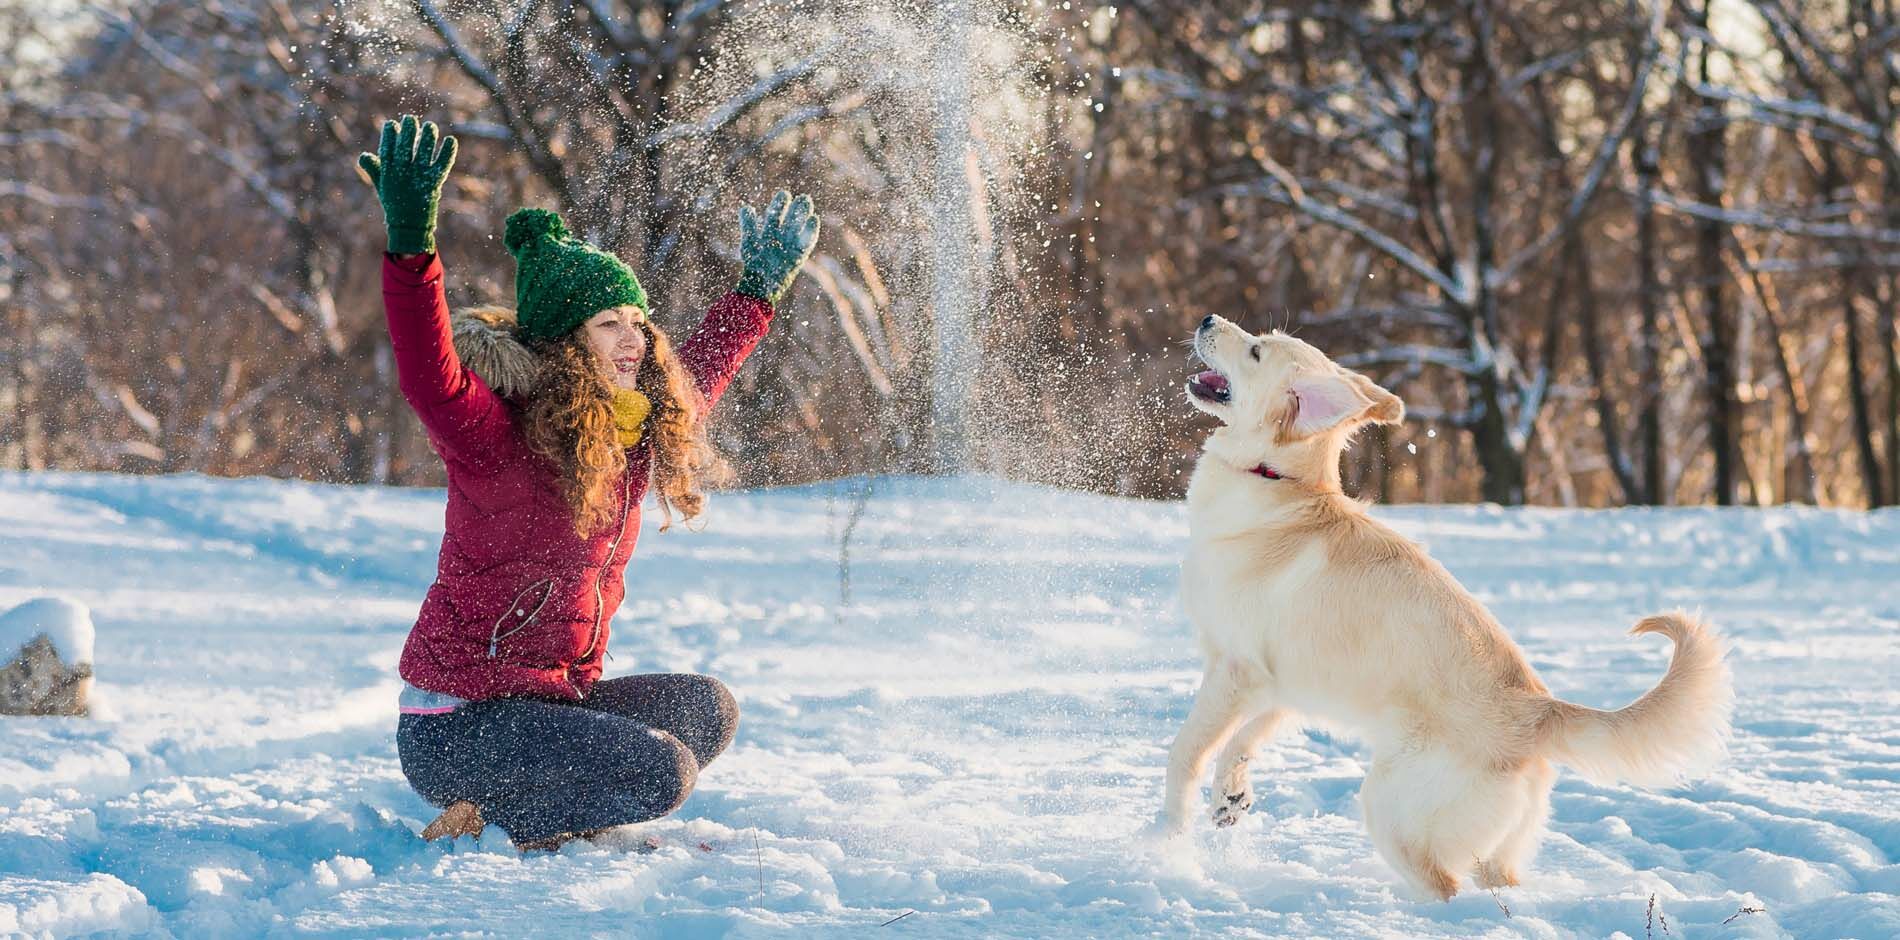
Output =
[{"x1": 0, "y1": 0, "x2": 1900, "y2": 507}]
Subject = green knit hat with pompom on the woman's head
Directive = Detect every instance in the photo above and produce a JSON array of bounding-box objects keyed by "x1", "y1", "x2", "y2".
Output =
[{"x1": 502, "y1": 209, "x2": 646, "y2": 340}]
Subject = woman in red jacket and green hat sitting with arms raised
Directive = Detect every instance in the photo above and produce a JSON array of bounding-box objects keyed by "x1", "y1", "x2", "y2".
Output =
[{"x1": 359, "y1": 118, "x2": 819, "y2": 851}]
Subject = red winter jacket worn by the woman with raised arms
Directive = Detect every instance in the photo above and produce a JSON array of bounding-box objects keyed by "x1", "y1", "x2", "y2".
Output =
[{"x1": 382, "y1": 254, "x2": 771, "y2": 699}]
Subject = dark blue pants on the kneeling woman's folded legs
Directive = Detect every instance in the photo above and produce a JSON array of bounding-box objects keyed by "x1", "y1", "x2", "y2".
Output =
[{"x1": 395, "y1": 674, "x2": 739, "y2": 841}]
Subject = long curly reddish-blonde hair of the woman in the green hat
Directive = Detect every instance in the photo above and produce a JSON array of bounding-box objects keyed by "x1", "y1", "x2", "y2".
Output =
[{"x1": 519, "y1": 319, "x2": 730, "y2": 537}]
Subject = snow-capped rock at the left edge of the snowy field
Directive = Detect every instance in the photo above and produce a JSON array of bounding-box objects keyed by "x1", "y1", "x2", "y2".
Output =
[{"x1": 0, "y1": 598, "x2": 93, "y2": 716}]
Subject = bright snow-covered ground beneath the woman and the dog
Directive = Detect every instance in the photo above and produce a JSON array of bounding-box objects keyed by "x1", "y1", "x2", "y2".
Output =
[{"x1": 0, "y1": 475, "x2": 1900, "y2": 938}]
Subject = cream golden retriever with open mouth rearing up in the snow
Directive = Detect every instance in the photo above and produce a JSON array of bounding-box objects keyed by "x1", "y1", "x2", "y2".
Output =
[{"x1": 1159, "y1": 317, "x2": 1733, "y2": 898}]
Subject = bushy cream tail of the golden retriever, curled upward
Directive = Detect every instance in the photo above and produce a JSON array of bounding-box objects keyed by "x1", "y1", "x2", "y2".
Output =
[{"x1": 1541, "y1": 613, "x2": 1735, "y2": 786}]
